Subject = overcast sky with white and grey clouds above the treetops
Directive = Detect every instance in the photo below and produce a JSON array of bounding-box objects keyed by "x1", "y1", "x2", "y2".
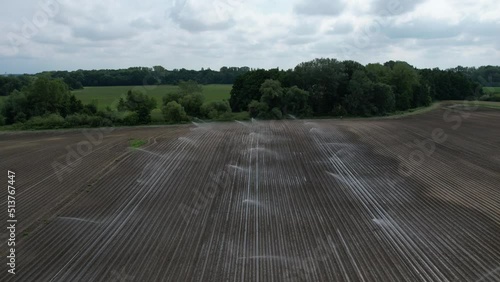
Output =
[{"x1": 0, "y1": 0, "x2": 500, "y2": 73}]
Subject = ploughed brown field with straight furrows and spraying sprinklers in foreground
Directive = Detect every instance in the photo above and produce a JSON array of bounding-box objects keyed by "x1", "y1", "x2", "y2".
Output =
[{"x1": 0, "y1": 104, "x2": 500, "y2": 281}]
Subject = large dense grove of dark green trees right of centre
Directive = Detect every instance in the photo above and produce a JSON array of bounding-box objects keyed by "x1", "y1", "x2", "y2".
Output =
[{"x1": 229, "y1": 58, "x2": 482, "y2": 118}]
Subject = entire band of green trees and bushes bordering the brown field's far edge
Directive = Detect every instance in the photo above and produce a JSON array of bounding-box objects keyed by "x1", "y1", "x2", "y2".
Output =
[{"x1": 0, "y1": 58, "x2": 497, "y2": 129}]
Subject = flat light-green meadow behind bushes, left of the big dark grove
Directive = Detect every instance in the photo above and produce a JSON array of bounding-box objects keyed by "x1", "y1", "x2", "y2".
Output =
[{"x1": 73, "y1": 84, "x2": 233, "y2": 109}]
